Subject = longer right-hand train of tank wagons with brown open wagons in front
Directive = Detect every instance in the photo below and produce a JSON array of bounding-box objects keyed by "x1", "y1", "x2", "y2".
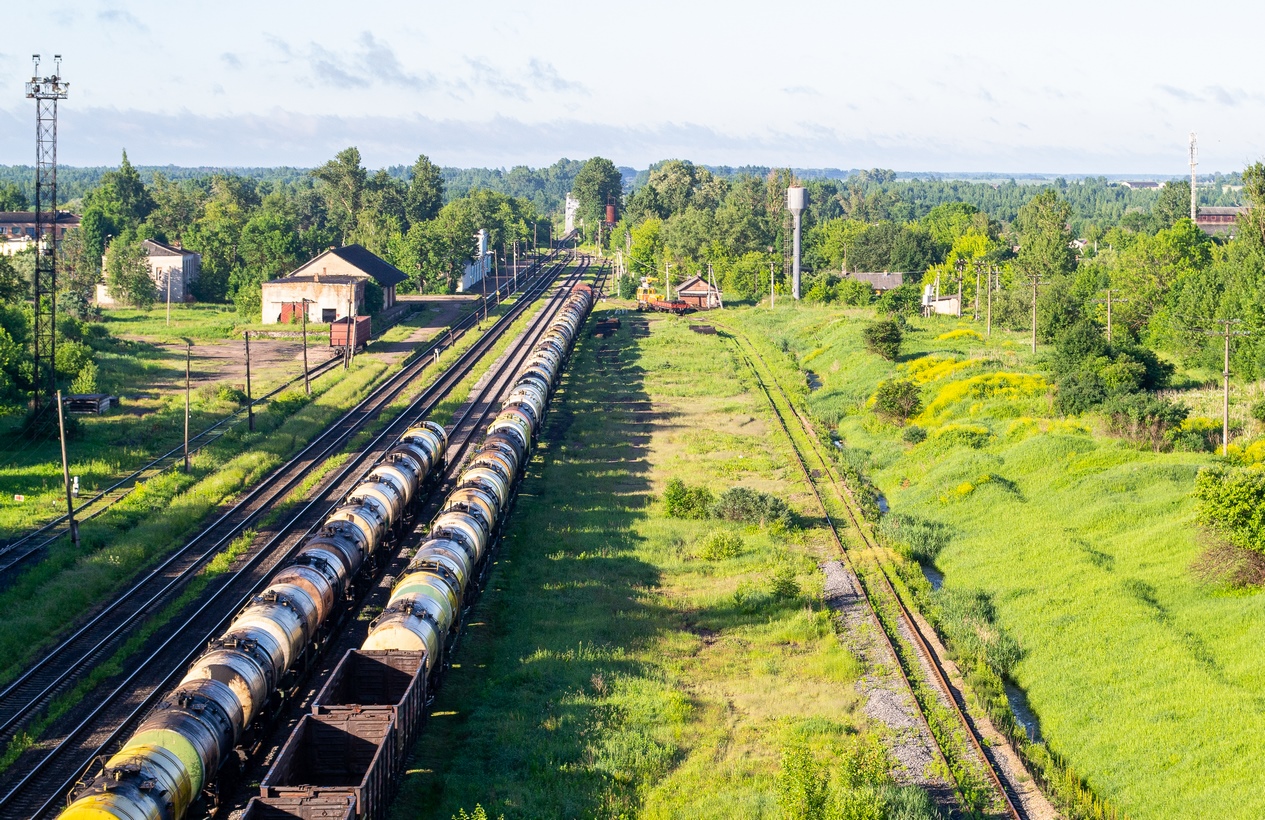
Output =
[{"x1": 243, "y1": 285, "x2": 593, "y2": 820}]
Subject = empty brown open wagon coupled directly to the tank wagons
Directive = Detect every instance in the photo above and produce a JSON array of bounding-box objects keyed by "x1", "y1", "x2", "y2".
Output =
[{"x1": 312, "y1": 649, "x2": 426, "y2": 766}]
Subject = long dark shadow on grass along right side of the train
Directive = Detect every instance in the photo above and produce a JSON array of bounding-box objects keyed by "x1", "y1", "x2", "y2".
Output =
[{"x1": 392, "y1": 316, "x2": 679, "y2": 817}]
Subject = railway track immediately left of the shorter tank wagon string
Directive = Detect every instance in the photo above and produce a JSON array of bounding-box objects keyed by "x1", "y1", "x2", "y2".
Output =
[{"x1": 0, "y1": 258, "x2": 581, "y2": 816}]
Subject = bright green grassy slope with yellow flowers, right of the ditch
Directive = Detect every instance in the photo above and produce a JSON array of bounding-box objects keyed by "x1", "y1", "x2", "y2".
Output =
[{"x1": 727, "y1": 308, "x2": 1265, "y2": 817}]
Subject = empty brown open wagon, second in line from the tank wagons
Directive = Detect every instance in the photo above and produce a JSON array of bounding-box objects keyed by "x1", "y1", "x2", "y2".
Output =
[{"x1": 259, "y1": 710, "x2": 398, "y2": 820}]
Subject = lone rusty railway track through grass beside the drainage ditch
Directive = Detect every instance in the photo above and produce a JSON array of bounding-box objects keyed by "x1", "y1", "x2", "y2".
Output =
[{"x1": 717, "y1": 324, "x2": 1027, "y2": 820}]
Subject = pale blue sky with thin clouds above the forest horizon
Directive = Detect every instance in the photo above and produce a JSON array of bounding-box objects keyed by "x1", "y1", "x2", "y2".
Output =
[{"x1": 0, "y1": 0, "x2": 1265, "y2": 176}]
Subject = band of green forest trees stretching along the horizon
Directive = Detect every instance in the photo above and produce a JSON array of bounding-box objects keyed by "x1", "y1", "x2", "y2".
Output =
[{"x1": 0, "y1": 147, "x2": 1265, "y2": 417}]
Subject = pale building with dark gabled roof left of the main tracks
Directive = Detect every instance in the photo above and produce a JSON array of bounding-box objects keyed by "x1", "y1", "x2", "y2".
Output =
[{"x1": 261, "y1": 244, "x2": 409, "y2": 324}]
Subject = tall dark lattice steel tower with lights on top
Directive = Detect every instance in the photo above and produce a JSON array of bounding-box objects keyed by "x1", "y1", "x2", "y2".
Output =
[{"x1": 27, "y1": 54, "x2": 70, "y2": 410}]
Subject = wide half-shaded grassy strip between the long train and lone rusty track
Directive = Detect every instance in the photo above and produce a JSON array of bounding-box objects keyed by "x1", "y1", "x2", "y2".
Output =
[{"x1": 393, "y1": 308, "x2": 946, "y2": 819}]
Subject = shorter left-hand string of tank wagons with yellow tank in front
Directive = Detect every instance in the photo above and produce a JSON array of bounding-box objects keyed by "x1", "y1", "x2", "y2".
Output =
[{"x1": 61, "y1": 421, "x2": 448, "y2": 820}]
